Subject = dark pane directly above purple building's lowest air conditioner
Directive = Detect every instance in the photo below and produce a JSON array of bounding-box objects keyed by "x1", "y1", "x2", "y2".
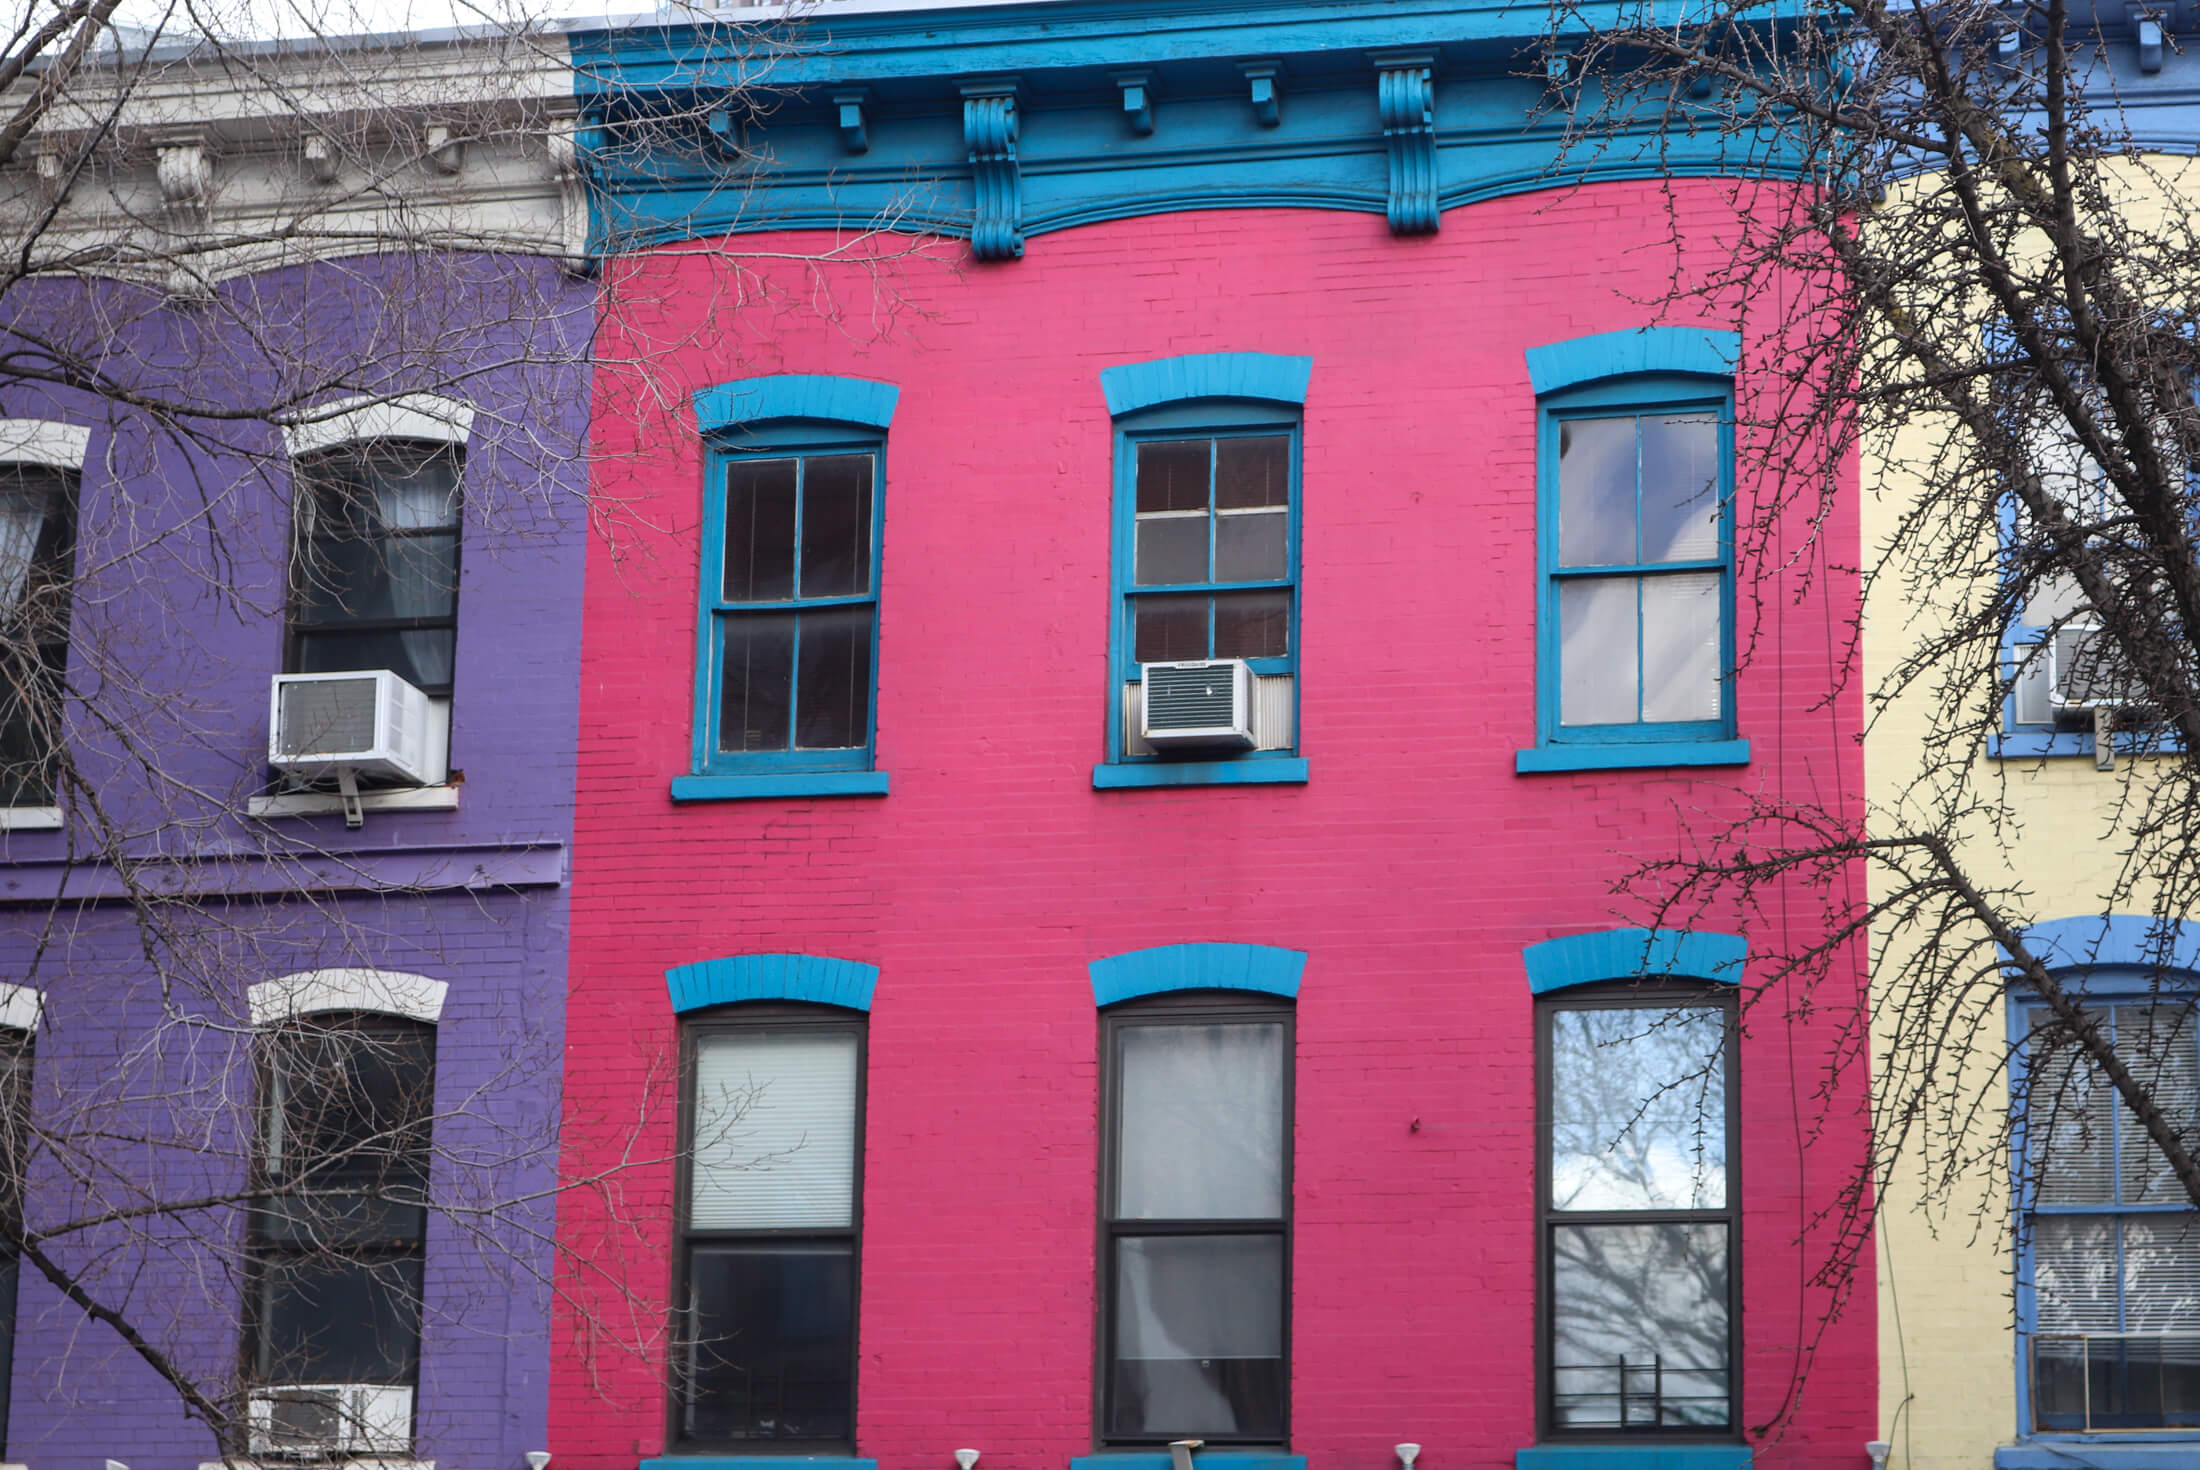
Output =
[{"x1": 257, "y1": 1252, "x2": 420, "y2": 1384}]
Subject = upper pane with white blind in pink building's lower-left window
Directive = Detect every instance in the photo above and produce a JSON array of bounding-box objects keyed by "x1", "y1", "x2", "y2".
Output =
[{"x1": 689, "y1": 1032, "x2": 856, "y2": 1230}]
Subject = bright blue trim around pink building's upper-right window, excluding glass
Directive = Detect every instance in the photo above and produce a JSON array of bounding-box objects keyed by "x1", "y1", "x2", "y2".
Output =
[{"x1": 1514, "y1": 341, "x2": 1749, "y2": 775}]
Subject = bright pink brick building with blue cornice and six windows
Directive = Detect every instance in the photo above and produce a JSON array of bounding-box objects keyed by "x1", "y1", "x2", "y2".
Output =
[{"x1": 550, "y1": 2, "x2": 1877, "y2": 1470}]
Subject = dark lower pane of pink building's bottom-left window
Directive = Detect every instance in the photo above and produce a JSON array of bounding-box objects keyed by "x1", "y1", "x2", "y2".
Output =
[{"x1": 684, "y1": 1243, "x2": 856, "y2": 1441}]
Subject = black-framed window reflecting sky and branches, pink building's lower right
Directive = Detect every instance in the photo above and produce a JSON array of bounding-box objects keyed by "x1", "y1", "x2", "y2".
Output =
[{"x1": 1536, "y1": 981, "x2": 1740, "y2": 1437}]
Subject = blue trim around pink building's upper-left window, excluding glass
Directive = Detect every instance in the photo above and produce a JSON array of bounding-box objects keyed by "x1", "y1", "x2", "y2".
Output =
[{"x1": 673, "y1": 374, "x2": 902, "y2": 801}]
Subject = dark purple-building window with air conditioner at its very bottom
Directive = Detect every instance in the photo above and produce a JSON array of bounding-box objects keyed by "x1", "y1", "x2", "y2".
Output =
[{"x1": 244, "y1": 1014, "x2": 436, "y2": 1452}]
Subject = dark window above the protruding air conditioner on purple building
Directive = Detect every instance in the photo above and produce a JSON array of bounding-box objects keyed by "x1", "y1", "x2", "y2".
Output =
[{"x1": 284, "y1": 440, "x2": 462, "y2": 698}]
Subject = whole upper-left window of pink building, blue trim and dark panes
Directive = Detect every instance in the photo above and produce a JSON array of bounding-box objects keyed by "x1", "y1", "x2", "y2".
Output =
[{"x1": 673, "y1": 374, "x2": 900, "y2": 801}]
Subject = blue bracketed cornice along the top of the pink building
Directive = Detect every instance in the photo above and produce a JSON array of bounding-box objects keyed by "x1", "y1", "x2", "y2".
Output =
[{"x1": 572, "y1": 0, "x2": 1773, "y2": 260}]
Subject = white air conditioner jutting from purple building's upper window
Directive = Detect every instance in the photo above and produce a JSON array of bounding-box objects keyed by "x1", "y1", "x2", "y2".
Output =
[{"x1": 268, "y1": 669, "x2": 429, "y2": 786}]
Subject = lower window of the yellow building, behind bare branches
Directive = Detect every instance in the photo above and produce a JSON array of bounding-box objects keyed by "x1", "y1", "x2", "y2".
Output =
[{"x1": 2017, "y1": 973, "x2": 2200, "y2": 1433}]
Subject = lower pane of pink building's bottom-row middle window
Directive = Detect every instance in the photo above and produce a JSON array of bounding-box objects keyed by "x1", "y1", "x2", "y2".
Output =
[{"x1": 1109, "y1": 1235, "x2": 1285, "y2": 1439}]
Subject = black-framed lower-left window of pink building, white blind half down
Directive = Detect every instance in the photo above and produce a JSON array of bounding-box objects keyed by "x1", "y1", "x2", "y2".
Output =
[{"x1": 671, "y1": 1008, "x2": 865, "y2": 1455}]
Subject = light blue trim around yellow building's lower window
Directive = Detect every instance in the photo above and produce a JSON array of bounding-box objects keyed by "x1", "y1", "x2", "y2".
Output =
[{"x1": 1993, "y1": 913, "x2": 2200, "y2": 1443}]
